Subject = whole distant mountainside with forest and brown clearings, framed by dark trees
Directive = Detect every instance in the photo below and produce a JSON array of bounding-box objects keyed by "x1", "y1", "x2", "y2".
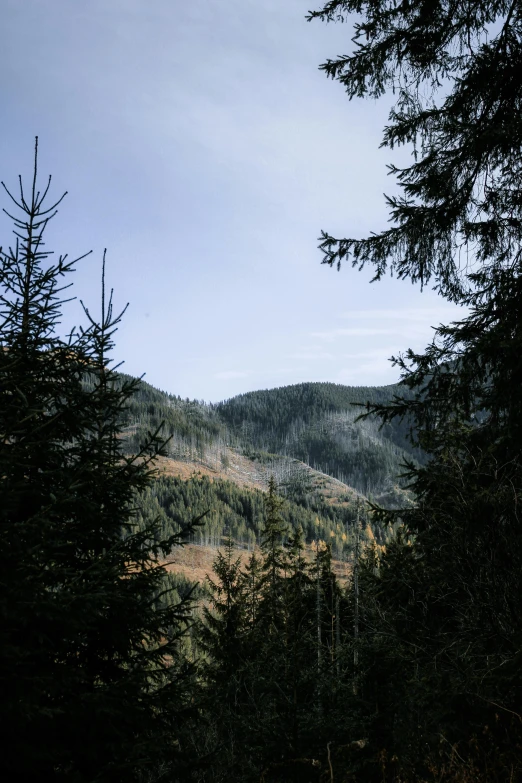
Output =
[{"x1": 110, "y1": 376, "x2": 414, "y2": 580}]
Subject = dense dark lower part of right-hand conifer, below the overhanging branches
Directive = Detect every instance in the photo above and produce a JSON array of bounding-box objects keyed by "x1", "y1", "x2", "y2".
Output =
[{"x1": 350, "y1": 230, "x2": 522, "y2": 780}]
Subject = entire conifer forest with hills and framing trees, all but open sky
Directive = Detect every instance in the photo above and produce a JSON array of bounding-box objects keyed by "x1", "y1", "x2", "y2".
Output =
[{"x1": 0, "y1": 0, "x2": 522, "y2": 783}]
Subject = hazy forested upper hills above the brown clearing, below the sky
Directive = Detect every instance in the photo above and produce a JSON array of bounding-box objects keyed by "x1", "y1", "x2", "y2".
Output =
[{"x1": 115, "y1": 376, "x2": 422, "y2": 495}]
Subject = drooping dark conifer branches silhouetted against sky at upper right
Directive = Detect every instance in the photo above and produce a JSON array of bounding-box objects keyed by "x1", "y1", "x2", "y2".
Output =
[{"x1": 302, "y1": 0, "x2": 522, "y2": 302}]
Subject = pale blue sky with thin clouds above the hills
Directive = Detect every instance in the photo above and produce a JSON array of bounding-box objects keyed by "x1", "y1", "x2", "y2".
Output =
[{"x1": 0, "y1": 0, "x2": 462, "y2": 402}]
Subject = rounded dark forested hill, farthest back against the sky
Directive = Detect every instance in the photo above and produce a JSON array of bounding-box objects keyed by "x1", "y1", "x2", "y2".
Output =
[{"x1": 212, "y1": 383, "x2": 421, "y2": 494}]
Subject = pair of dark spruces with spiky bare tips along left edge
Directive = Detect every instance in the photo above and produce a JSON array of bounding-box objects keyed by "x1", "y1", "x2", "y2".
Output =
[{"x1": 0, "y1": 141, "x2": 200, "y2": 783}]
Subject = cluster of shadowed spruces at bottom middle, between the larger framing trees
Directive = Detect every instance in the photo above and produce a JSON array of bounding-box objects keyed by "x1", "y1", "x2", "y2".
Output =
[{"x1": 194, "y1": 482, "x2": 366, "y2": 782}]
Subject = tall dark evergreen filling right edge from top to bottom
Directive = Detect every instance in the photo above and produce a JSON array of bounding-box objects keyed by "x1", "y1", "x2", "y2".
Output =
[{"x1": 309, "y1": 0, "x2": 522, "y2": 781}]
